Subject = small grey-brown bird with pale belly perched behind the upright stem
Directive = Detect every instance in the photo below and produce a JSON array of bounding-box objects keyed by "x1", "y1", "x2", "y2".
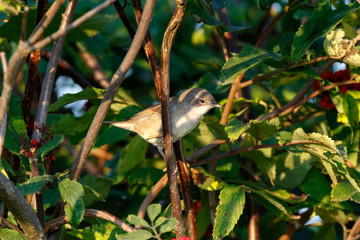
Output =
[{"x1": 104, "y1": 88, "x2": 222, "y2": 156}]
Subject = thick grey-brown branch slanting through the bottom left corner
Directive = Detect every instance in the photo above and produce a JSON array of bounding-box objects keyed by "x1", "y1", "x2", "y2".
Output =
[{"x1": 0, "y1": 173, "x2": 44, "y2": 240}]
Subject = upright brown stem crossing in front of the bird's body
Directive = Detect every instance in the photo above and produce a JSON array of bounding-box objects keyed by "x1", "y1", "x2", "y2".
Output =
[{"x1": 159, "y1": 0, "x2": 186, "y2": 238}]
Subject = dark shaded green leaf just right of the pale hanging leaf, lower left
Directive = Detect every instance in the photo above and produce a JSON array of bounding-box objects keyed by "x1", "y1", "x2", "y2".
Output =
[{"x1": 80, "y1": 175, "x2": 112, "y2": 207}]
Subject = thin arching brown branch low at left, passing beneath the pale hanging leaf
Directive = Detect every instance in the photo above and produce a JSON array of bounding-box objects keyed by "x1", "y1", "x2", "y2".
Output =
[{"x1": 45, "y1": 209, "x2": 135, "y2": 233}]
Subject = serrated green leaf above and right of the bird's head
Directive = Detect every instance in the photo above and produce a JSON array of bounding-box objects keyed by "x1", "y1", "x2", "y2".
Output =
[{"x1": 220, "y1": 44, "x2": 280, "y2": 85}]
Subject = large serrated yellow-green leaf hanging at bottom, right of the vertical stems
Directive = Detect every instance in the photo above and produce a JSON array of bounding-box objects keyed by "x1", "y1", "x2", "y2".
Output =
[{"x1": 213, "y1": 185, "x2": 245, "y2": 239}]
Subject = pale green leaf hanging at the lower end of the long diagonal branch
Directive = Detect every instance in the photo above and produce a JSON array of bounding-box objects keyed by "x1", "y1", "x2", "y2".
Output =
[{"x1": 59, "y1": 178, "x2": 85, "y2": 225}]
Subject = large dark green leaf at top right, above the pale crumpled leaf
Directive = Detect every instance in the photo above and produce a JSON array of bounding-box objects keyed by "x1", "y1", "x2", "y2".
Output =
[{"x1": 291, "y1": 0, "x2": 360, "y2": 61}]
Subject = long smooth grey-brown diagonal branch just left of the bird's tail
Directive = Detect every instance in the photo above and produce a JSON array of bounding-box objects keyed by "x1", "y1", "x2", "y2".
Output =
[{"x1": 70, "y1": 0, "x2": 156, "y2": 180}]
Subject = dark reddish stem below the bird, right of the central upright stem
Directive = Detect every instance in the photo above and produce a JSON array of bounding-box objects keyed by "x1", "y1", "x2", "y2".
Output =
[{"x1": 174, "y1": 139, "x2": 198, "y2": 240}]
